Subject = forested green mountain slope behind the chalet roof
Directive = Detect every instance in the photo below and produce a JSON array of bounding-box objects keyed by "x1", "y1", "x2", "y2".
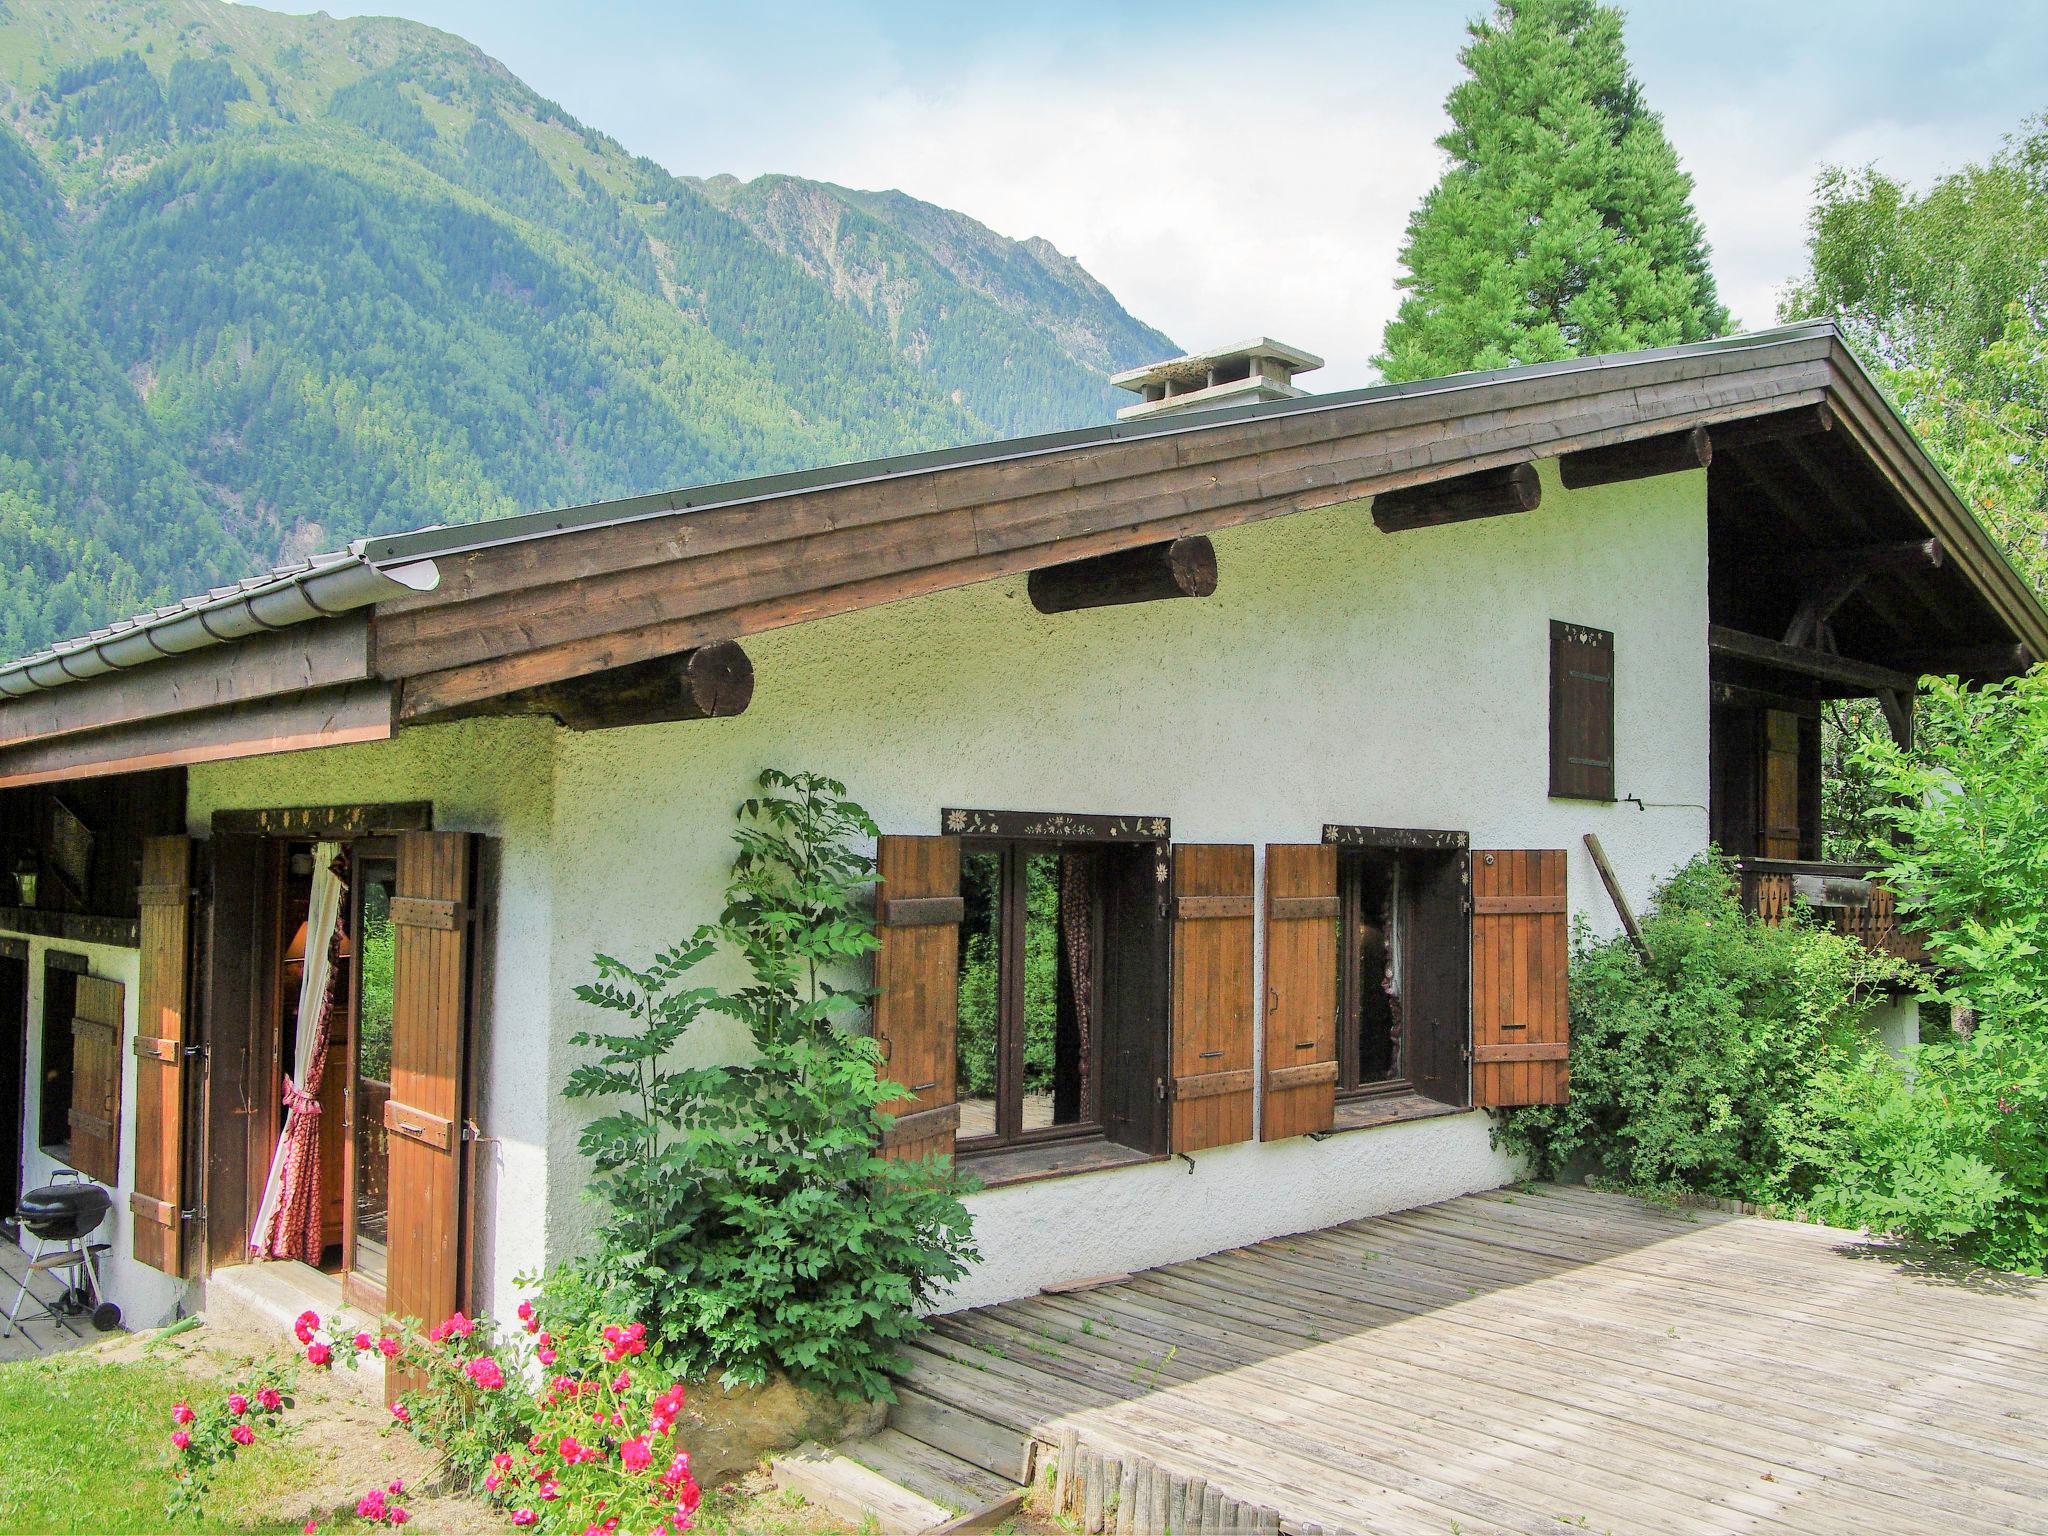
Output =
[{"x1": 0, "y1": 0, "x2": 1176, "y2": 651}]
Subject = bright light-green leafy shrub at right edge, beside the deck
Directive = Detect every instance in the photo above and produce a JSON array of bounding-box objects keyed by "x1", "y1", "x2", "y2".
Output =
[{"x1": 1794, "y1": 668, "x2": 2048, "y2": 1274}]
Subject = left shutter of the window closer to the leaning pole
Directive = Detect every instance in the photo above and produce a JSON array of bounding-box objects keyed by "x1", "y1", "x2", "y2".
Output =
[{"x1": 1260, "y1": 844, "x2": 1337, "y2": 1141}]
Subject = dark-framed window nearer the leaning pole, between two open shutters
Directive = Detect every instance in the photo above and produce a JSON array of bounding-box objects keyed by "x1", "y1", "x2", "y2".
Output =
[{"x1": 1323, "y1": 827, "x2": 1470, "y2": 1104}]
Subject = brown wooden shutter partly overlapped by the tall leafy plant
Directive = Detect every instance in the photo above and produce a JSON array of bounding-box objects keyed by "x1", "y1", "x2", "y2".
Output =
[{"x1": 874, "y1": 836, "x2": 963, "y2": 1161}]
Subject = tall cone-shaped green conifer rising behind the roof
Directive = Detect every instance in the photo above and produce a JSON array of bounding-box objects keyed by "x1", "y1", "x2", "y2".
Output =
[{"x1": 1374, "y1": 0, "x2": 1729, "y2": 379}]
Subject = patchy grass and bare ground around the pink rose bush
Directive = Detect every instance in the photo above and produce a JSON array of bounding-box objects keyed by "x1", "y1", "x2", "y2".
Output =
[{"x1": 0, "y1": 1329, "x2": 850, "y2": 1536}]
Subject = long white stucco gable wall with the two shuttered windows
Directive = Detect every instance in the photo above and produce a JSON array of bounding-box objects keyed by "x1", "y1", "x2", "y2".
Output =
[{"x1": 547, "y1": 465, "x2": 1708, "y2": 1305}]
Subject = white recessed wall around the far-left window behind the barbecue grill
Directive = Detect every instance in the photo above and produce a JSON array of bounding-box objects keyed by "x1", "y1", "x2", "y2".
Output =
[{"x1": 0, "y1": 934, "x2": 184, "y2": 1333}]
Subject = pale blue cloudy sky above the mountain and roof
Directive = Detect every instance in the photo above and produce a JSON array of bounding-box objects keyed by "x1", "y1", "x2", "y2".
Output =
[{"x1": 296, "y1": 0, "x2": 2048, "y2": 389}]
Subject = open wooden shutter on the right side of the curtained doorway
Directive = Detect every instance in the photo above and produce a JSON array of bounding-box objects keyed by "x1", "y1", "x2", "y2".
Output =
[{"x1": 385, "y1": 831, "x2": 477, "y2": 1397}]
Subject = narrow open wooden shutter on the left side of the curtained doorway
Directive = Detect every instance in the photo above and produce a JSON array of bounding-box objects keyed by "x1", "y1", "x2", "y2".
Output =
[{"x1": 129, "y1": 838, "x2": 193, "y2": 1274}]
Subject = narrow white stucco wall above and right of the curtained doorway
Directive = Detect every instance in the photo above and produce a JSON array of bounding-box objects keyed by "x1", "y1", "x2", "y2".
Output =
[{"x1": 186, "y1": 719, "x2": 567, "y2": 1315}]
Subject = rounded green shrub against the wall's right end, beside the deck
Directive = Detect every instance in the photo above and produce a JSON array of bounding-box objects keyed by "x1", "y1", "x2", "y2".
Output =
[{"x1": 1495, "y1": 854, "x2": 1903, "y2": 1200}]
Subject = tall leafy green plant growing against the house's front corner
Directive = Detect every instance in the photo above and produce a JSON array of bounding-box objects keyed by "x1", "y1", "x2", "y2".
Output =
[{"x1": 551, "y1": 770, "x2": 977, "y2": 1399}]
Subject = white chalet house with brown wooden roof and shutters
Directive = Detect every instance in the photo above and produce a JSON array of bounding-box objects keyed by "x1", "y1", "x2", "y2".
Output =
[{"x1": 0, "y1": 324, "x2": 2048, "y2": 1359}]
